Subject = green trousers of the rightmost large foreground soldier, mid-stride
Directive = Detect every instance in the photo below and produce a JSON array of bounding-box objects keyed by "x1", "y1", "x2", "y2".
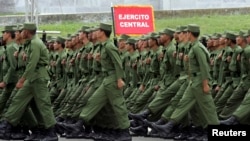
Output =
[{"x1": 170, "y1": 76, "x2": 219, "y2": 125}]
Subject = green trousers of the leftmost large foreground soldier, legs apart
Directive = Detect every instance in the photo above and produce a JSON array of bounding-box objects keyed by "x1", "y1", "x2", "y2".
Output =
[{"x1": 5, "y1": 78, "x2": 56, "y2": 128}]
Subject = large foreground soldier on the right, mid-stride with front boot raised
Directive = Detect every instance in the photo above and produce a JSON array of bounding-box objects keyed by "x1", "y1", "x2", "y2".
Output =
[{"x1": 150, "y1": 24, "x2": 219, "y2": 141}]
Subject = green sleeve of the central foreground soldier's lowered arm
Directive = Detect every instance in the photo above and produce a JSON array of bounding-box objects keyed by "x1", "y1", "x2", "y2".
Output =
[{"x1": 105, "y1": 45, "x2": 124, "y2": 79}]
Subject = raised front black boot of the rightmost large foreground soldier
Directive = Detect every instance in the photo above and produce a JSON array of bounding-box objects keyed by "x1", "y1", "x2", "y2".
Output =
[{"x1": 152, "y1": 121, "x2": 175, "y2": 134}]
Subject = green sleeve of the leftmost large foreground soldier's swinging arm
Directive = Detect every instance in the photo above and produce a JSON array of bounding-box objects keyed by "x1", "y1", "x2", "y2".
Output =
[{"x1": 22, "y1": 41, "x2": 41, "y2": 79}]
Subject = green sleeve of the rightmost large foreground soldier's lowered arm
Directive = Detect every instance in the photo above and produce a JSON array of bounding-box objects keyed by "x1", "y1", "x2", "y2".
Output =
[{"x1": 193, "y1": 47, "x2": 210, "y2": 80}]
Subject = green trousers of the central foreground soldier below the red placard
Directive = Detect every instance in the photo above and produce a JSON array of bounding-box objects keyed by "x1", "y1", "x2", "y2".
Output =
[{"x1": 80, "y1": 75, "x2": 130, "y2": 129}]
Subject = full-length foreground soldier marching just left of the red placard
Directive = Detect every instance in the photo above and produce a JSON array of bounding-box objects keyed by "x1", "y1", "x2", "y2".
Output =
[{"x1": 61, "y1": 23, "x2": 132, "y2": 141}]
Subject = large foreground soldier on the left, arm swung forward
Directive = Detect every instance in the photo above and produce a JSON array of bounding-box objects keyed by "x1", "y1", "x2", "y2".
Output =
[{"x1": 0, "y1": 23, "x2": 58, "y2": 141}]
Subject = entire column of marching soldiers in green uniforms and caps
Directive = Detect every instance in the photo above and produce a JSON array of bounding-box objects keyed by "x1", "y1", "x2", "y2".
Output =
[{"x1": 0, "y1": 20, "x2": 250, "y2": 141}]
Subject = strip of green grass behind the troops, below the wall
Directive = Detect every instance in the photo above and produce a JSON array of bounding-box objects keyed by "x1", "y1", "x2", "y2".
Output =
[{"x1": 39, "y1": 14, "x2": 250, "y2": 36}]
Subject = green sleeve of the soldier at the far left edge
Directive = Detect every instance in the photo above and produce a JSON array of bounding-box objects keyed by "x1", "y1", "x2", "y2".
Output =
[{"x1": 3, "y1": 46, "x2": 17, "y2": 84}]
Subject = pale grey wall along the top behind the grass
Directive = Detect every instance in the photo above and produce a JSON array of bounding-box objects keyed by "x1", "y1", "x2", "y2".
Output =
[{"x1": 0, "y1": 0, "x2": 250, "y2": 14}]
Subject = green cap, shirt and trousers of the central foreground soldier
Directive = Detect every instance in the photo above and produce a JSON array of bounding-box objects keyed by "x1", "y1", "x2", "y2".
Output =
[{"x1": 80, "y1": 24, "x2": 129, "y2": 129}]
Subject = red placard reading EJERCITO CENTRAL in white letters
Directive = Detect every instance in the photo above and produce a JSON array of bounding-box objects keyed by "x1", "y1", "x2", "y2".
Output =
[{"x1": 113, "y1": 5, "x2": 155, "y2": 36}]
